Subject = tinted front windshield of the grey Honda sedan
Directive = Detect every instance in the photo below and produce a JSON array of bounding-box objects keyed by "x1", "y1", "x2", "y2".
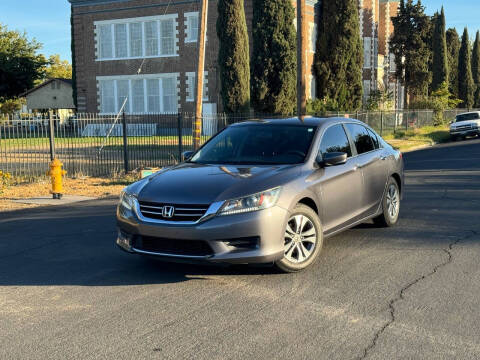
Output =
[{"x1": 190, "y1": 124, "x2": 315, "y2": 165}]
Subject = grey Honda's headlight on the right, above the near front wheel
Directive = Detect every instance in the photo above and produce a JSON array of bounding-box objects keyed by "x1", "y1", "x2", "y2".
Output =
[{"x1": 219, "y1": 188, "x2": 280, "y2": 215}]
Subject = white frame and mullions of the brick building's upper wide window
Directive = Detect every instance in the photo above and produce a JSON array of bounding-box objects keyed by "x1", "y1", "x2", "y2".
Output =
[{"x1": 94, "y1": 14, "x2": 179, "y2": 61}]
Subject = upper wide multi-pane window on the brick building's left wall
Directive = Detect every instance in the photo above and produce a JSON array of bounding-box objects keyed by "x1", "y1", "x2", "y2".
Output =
[{"x1": 95, "y1": 14, "x2": 178, "y2": 60}]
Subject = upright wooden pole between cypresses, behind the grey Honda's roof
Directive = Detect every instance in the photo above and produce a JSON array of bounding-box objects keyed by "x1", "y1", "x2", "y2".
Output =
[{"x1": 297, "y1": 0, "x2": 307, "y2": 120}]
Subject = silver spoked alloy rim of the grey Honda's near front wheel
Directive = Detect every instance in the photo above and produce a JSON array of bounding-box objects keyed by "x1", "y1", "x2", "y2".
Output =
[{"x1": 285, "y1": 215, "x2": 317, "y2": 264}]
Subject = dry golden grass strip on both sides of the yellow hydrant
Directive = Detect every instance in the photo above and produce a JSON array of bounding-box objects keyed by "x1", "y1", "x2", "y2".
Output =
[{"x1": 0, "y1": 176, "x2": 137, "y2": 212}]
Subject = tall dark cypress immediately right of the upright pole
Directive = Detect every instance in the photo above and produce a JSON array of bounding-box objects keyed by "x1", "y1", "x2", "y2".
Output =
[{"x1": 313, "y1": 0, "x2": 363, "y2": 111}]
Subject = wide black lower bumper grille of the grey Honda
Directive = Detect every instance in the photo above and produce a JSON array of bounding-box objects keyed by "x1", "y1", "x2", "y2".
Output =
[{"x1": 134, "y1": 236, "x2": 213, "y2": 256}]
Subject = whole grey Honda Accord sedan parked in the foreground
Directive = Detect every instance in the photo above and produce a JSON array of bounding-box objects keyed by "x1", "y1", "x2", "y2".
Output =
[{"x1": 117, "y1": 118, "x2": 403, "y2": 272}]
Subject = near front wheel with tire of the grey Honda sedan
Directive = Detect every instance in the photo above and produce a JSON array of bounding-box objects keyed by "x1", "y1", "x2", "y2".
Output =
[{"x1": 275, "y1": 204, "x2": 323, "y2": 273}]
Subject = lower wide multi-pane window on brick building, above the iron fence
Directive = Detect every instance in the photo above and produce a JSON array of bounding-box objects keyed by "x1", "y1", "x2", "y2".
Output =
[{"x1": 97, "y1": 74, "x2": 178, "y2": 114}]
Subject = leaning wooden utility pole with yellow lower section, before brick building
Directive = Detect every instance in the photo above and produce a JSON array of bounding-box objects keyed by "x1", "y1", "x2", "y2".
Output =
[{"x1": 193, "y1": 0, "x2": 208, "y2": 150}]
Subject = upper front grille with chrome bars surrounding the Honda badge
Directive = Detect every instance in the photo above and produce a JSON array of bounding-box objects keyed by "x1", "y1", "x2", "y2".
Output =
[{"x1": 140, "y1": 201, "x2": 209, "y2": 222}]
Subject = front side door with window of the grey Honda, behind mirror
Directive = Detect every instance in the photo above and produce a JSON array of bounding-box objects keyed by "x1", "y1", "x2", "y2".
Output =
[{"x1": 316, "y1": 124, "x2": 363, "y2": 233}]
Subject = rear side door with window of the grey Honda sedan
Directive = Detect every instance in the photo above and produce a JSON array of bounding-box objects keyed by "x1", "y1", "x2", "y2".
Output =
[{"x1": 346, "y1": 123, "x2": 387, "y2": 216}]
